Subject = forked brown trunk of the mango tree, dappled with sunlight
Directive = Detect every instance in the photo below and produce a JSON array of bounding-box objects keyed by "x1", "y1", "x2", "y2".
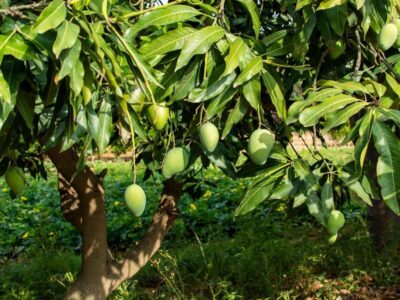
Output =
[{"x1": 47, "y1": 148, "x2": 182, "y2": 300}]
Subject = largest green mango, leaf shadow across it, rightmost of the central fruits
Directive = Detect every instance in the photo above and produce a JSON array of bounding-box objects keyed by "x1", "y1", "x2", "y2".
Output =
[{"x1": 247, "y1": 129, "x2": 275, "y2": 165}]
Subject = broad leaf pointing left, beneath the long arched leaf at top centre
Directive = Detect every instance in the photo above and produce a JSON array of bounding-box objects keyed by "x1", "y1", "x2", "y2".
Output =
[{"x1": 139, "y1": 27, "x2": 196, "y2": 60}]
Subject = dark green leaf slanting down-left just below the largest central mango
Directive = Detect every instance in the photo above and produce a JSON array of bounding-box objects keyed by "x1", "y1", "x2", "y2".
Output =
[{"x1": 235, "y1": 167, "x2": 286, "y2": 216}]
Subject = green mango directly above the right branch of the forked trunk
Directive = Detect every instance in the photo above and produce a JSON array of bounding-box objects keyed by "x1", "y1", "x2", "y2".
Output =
[{"x1": 162, "y1": 147, "x2": 189, "y2": 179}]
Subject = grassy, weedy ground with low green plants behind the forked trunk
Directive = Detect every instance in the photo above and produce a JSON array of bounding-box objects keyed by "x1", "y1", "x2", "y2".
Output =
[{"x1": 0, "y1": 151, "x2": 400, "y2": 299}]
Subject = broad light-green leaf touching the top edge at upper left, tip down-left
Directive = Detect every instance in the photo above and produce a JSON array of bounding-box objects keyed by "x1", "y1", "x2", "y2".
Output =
[{"x1": 33, "y1": 0, "x2": 67, "y2": 33}]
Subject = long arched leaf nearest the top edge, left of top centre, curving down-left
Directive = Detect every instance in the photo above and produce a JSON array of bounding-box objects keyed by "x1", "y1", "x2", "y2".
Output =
[{"x1": 124, "y1": 5, "x2": 200, "y2": 41}]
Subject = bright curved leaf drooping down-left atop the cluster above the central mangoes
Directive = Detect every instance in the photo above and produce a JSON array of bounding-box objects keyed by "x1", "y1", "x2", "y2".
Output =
[{"x1": 175, "y1": 26, "x2": 225, "y2": 71}]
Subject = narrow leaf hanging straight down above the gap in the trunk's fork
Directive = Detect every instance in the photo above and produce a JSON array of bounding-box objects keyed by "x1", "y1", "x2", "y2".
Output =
[{"x1": 95, "y1": 94, "x2": 113, "y2": 154}]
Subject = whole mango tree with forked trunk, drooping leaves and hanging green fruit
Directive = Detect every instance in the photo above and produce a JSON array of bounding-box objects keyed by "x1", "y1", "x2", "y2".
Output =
[{"x1": 0, "y1": 0, "x2": 400, "y2": 299}]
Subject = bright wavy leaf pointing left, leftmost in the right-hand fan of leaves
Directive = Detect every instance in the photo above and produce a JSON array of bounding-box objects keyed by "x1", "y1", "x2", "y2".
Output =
[{"x1": 299, "y1": 94, "x2": 360, "y2": 127}]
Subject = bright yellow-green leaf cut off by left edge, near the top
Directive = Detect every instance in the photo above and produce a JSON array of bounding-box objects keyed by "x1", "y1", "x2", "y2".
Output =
[{"x1": 0, "y1": 34, "x2": 36, "y2": 60}]
